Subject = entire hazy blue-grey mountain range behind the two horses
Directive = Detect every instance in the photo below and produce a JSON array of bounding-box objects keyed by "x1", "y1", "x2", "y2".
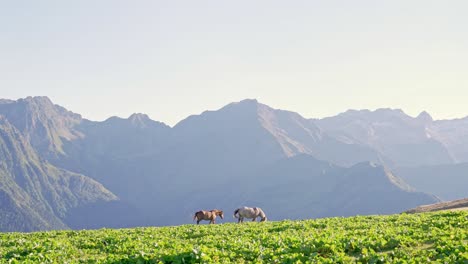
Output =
[{"x1": 0, "y1": 97, "x2": 468, "y2": 231}]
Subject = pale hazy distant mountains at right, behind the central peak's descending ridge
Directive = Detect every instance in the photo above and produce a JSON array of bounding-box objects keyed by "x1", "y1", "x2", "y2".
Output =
[{"x1": 313, "y1": 109, "x2": 468, "y2": 200}]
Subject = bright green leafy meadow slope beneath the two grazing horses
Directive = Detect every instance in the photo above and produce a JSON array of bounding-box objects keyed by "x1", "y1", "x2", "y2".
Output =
[{"x1": 0, "y1": 212, "x2": 468, "y2": 263}]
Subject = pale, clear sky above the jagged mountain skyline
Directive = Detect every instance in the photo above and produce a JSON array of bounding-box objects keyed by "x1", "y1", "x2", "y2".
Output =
[{"x1": 0, "y1": 0, "x2": 468, "y2": 125}]
